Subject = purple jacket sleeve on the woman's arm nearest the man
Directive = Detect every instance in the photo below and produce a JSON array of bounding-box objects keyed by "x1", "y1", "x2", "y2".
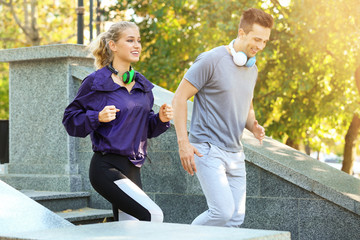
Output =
[{"x1": 148, "y1": 92, "x2": 170, "y2": 138}]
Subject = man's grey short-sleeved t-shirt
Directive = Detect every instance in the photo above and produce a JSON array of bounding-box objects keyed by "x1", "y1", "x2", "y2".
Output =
[{"x1": 184, "y1": 46, "x2": 258, "y2": 152}]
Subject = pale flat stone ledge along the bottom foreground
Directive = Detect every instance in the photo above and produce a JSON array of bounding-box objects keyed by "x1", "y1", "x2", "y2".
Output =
[{"x1": 1, "y1": 221, "x2": 291, "y2": 240}]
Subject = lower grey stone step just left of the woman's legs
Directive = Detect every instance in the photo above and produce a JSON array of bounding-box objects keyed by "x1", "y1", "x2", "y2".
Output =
[{"x1": 56, "y1": 207, "x2": 113, "y2": 225}]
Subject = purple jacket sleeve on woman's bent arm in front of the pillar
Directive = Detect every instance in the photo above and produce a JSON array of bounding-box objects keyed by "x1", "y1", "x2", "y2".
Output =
[{"x1": 62, "y1": 77, "x2": 100, "y2": 137}]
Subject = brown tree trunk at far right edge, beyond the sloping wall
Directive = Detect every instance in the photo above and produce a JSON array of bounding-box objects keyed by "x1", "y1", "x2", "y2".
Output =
[{"x1": 341, "y1": 114, "x2": 360, "y2": 175}]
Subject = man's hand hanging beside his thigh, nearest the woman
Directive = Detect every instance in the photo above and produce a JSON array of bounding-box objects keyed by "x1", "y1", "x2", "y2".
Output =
[{"x1": 179, "y1": 141, "x2": 203, "y2": 176}]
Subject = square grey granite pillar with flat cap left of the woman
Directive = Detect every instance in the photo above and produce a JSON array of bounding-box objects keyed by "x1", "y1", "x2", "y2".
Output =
[{"x1": 0, "y1": 44, "x2": 93, "y2": 191}]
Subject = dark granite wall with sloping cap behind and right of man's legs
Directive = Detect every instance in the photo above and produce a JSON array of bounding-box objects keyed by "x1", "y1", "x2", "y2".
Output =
[{"x1": 142, "y1": 117, "x2": 360, "y2": 240}]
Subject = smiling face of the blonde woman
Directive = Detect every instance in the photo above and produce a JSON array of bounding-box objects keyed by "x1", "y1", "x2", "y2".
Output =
[{"x1": 110, "y1": 27, "x2": 141, "y2": 63}]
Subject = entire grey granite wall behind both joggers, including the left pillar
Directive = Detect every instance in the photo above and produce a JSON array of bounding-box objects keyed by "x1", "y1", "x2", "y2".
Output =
[{"x1": 0, "y1": 44, "x2": 360, "y2": 240}]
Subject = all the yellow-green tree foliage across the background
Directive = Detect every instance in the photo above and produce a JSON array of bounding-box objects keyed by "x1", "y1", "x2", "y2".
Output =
[{"x1": 0, "y1": 0, "x2": 360, "y2": 154}]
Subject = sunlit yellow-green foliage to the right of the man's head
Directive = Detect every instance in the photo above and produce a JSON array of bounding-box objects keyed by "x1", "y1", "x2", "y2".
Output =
[{"x1": 255, "y1": 0, "x2": 360, "y2": 150}]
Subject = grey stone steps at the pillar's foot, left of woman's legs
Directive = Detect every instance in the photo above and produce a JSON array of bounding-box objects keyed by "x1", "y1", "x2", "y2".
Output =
[{"x1": 21, "y1": 190, "x2": 113, "y2": 225}]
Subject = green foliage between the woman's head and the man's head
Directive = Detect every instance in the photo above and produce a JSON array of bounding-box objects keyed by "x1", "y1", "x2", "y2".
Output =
[{"x1": 104, "y1": 0, "x2": 262, "y2": 91}]
